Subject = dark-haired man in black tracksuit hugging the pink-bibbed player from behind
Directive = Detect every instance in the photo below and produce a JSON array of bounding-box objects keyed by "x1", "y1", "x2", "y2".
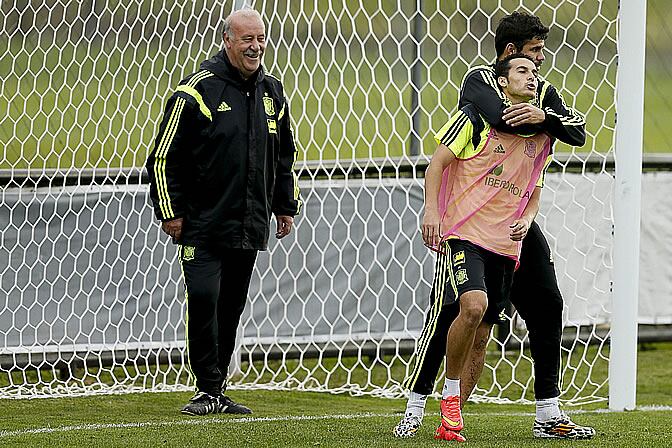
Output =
[{"x1": 393, "y1": 11, "x2": 595, "y2": 440}]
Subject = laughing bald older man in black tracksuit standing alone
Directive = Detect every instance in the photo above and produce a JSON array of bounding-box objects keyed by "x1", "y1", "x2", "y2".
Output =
[{"x1": 146, "y1": 9, "x2": 301, "y2": 415}]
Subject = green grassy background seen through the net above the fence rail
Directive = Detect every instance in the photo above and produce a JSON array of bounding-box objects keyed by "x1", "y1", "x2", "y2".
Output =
[{"x1": 0, "y1": 0, "x2": 672, "y2": 169}]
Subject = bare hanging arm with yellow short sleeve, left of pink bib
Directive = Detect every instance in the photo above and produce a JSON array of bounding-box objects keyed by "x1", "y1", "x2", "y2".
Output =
[{"x1": 421, "y1": 110, "x2": 474, "y2": 246}]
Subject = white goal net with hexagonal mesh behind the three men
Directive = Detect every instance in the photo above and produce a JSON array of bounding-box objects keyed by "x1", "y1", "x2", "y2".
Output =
[{"x1": 0, "y1": 0, "x2": 618, "y2": 403}]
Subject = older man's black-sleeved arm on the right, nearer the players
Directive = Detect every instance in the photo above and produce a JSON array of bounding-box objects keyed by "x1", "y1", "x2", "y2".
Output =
[{"x1": 272, "y1": 95, "x2": 302, "y2": 238}]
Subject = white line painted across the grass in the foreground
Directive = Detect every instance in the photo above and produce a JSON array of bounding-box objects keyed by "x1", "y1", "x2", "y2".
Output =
[{"x1": 0, "y1": 405, "x2": 672, "y2": 439}]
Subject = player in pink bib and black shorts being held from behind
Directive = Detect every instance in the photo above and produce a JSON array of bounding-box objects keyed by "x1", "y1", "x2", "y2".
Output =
[{"x1": 422, "y1": 54, "x2": 552, "y2": 441}]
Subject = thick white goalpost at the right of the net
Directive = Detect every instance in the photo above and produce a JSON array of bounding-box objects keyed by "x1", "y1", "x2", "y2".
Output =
[{"x1": 609, "y1": 0, "x2": 646, "y2": 411}]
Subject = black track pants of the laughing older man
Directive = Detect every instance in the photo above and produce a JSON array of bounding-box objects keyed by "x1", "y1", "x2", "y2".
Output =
[{"x1": 179, "y1": 246, "x2": 257, "y2": 394}]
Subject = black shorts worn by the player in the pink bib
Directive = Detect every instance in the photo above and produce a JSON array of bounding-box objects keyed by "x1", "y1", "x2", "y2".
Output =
[{"x1": 436, "y1": 239, "x2": 516, "y2": 325}]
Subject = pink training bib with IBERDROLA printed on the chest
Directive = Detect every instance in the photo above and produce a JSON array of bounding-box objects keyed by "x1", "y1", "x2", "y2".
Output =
[{"x1": 439, "y1": 129, "x2": 551, "y2": 262}]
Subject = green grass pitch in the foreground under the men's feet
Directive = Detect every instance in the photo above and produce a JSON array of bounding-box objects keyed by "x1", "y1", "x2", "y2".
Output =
[{"x1": 0, "y1": 343, "x2": 672, "y2": 448}]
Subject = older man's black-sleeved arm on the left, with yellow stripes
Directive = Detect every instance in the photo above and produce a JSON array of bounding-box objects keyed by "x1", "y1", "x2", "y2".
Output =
[{"x1": 145, "y1": 92, "x2": 207, "y2": 240}]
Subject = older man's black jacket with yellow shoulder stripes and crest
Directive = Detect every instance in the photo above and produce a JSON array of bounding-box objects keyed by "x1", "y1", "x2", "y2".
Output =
[{"x1": 146, "y1": 51, "x2": 301, "y2": 250}]
